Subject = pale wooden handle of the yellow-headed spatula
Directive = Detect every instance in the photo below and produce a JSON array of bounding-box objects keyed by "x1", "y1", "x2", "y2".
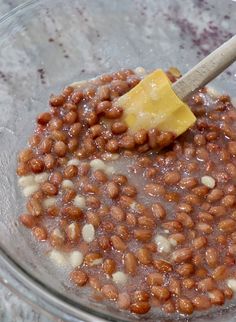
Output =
[{"x1": 172, "y1": 35, "x2": 236, "y2": 101}]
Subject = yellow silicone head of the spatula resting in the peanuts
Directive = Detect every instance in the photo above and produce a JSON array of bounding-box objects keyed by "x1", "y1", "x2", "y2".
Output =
[{"x1": 117, "y1": 69, "x2": 196, "y2": 135}]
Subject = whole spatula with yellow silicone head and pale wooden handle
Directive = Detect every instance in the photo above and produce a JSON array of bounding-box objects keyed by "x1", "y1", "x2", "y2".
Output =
[{"x1": 117, "y1": 36, "x2": 236, "y2": 136}]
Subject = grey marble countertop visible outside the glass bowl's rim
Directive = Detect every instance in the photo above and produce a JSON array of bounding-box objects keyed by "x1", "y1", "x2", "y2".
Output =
[{"x1": 0, "y1": 0, "x2": 56, "y2": 322}]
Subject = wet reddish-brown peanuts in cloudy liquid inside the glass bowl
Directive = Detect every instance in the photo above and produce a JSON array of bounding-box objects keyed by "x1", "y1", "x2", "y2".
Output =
[{"x1": 17, "y1": 69, "x2": 236, "y2": 314}]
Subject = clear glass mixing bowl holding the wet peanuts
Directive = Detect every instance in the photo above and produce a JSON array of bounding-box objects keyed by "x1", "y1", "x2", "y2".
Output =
[{"x1": 0, "y1": 0, "x2": 236, "y2": 322}]
